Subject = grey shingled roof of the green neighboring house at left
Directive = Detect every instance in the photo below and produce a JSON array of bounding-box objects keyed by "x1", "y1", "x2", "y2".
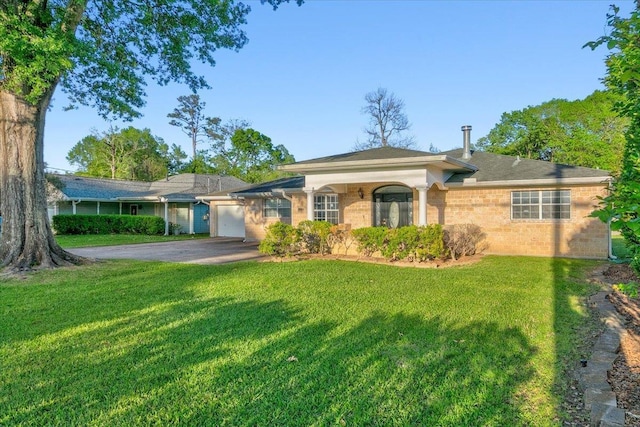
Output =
[{"x1": 47, "y1": 173, "x2": 246, "y2": 201}]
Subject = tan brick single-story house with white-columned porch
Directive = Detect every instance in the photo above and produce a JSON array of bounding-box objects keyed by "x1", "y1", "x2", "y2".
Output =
[{"x1": 200, "y1": 127, "x2": 610, "y2": 258}]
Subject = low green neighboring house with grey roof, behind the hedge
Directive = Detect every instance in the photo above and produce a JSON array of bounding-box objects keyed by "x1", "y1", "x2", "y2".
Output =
[{"x1": 48, "y1": 173, "x2": 246, "y2": 234}]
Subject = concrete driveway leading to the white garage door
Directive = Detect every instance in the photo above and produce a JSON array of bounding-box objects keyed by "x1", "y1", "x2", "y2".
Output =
[{"x1": 68, "y1": 238, "x2": 264, "y2": 264}]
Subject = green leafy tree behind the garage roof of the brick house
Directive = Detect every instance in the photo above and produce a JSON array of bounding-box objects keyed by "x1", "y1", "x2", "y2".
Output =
[{"x1": 213, "y1": 128, "x2": 295, "y2": 182}]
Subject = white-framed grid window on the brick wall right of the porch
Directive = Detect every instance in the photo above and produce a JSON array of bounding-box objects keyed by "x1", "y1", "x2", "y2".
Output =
[{"x1": 511, "y1": 190, "x2": 571, "y2": 219}]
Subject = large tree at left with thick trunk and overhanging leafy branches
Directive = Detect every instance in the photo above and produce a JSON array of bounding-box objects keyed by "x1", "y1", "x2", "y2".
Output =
[{"x1": 0, "y1": 0, "x2": 302, "y2": 270}]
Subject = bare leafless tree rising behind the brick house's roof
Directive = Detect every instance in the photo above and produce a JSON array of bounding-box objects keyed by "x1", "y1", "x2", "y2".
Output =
[{"x1": 355, "y1": 88, "x2": 415, "y2": 150}]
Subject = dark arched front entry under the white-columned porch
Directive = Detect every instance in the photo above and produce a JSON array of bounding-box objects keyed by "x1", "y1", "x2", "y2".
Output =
[{"x1": 373, "y1": 185, "x2": 413, "y2": 228}]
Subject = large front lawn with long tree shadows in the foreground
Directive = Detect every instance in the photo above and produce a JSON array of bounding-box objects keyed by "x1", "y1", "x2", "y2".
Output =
[{"x1": 0, "y1": 257, "x2": 596, "y2": 426}]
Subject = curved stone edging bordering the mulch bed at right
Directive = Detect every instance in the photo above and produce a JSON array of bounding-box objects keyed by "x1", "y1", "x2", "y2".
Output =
[{"x1": 580, "y1": 292, "x2": 627, "y2": 427}]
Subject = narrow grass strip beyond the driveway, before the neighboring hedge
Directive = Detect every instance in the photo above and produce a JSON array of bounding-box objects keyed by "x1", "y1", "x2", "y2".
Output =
[{"x1": 56, "y1": 234, "x2": 209, "y2": 248}]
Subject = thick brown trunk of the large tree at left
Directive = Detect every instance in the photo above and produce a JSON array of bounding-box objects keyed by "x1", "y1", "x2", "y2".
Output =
[{"x1": 0, "y1": 90, "x2": 83, "y2": 271}]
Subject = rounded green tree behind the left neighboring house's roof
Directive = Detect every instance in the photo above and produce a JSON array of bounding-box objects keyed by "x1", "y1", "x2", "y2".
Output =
[{"x1": 67, "y1": 127, "x2": 169, "y2": 181}]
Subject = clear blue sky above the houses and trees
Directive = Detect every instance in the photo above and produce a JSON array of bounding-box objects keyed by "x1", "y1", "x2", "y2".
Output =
[{"x1": 45, "y1": 0, "x2": 633, "y2": 174}]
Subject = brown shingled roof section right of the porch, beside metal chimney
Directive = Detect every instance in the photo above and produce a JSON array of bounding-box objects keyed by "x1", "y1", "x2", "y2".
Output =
[{"x1": 442, "y1": 148, "x2": 610, "y2": 184}]
